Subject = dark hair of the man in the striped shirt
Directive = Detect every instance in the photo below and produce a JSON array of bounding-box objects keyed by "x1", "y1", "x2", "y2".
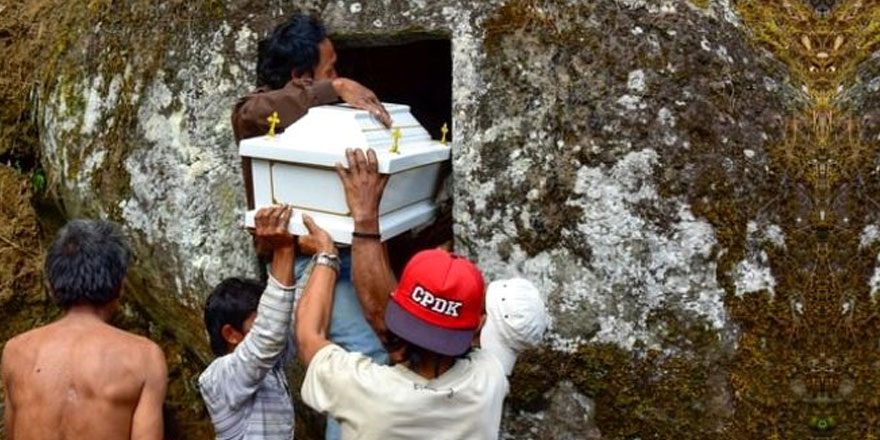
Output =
[{"x1": 205, "y1": 277, "x2": 266, "y2": 356}]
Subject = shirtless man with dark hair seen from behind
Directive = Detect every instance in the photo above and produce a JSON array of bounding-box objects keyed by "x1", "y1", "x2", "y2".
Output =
[{"x1": 2, "y1": 220, "x2": 167, "y2": 440}]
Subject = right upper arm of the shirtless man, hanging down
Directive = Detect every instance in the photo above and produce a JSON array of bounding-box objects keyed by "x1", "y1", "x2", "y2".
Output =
[{"x1": 131, "y1": 342, "x2": 168, "y2": 440}]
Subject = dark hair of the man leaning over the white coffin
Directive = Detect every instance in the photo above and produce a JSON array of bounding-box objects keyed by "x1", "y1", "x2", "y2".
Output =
[{"x1": 257, "y1": 14, "x2": 327, "y2": 90}]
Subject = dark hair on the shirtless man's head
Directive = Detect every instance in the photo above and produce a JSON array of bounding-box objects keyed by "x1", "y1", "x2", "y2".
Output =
[{"x1": 45, "y1": 220, "x2": 131, "y2": 309}]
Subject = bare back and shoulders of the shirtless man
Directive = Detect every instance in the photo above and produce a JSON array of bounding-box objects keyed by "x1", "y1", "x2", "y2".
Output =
[{"x1": 2, "y1": 318, "x2": 167, "y2": 440}]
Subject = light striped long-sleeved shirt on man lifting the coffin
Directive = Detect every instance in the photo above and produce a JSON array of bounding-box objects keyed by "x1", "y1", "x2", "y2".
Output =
[{"x1": 199, "y1": 276, "x2": 295, "y2": 440}]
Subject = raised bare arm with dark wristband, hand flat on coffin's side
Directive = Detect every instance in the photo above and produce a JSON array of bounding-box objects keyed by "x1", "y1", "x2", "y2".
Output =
[{"x1": 336, "y1": 149, "x2": 397, "y2": 345}]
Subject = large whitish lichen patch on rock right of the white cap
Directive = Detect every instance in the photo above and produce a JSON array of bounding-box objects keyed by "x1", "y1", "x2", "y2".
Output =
[{"x1": 459, "y1": 149, "x2": 727, "y2": 351}]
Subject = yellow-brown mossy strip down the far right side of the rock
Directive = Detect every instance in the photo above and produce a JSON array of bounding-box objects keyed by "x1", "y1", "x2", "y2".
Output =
[{"x1": 720, "y1": 0, "x2": 880, "y2": 438}]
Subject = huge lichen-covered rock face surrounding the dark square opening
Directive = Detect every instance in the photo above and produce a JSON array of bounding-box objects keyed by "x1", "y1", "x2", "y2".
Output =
[{"x1": 0, "y1": 0, "x2": 880, "y2": 439}]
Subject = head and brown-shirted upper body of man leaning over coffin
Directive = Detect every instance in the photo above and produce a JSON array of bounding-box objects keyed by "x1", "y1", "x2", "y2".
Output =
[{"x1": 232, "y1": 15, "x2": 391, "y2": 209}]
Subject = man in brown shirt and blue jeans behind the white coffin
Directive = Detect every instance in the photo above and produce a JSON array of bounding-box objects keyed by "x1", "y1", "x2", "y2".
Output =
[{"x1": 232, "y1": 15, "x2": 391, "y2": 440}]
